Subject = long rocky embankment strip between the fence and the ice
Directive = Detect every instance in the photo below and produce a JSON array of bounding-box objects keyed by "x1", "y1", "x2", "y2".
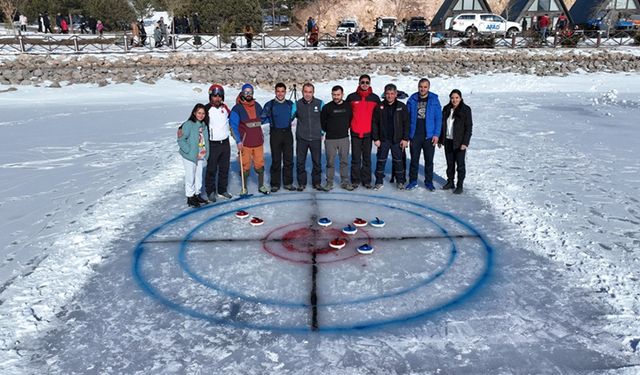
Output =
[{"x1": 0, "y1": 49, "x2": 640, "y2": 87}]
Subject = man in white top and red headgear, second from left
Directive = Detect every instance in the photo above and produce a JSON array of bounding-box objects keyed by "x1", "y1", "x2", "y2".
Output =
[{"x1": 205, "y1": 84, "x2": 232, "y2": 202}]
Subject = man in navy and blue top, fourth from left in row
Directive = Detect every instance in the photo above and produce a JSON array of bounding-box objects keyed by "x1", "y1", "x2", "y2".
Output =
[{"x1": 262, "y1": 82, "x2": 296, "y2": 193}]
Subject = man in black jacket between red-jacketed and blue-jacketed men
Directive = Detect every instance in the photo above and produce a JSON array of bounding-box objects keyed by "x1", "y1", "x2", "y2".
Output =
[{"x1": 371, "y1": 83, "x2": 409, "y2": 190}]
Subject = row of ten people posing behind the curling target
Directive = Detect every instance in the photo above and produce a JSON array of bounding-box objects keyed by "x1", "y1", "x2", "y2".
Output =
[{"x1": 178, "y1": 74, "x2": 473, "y2": 207}]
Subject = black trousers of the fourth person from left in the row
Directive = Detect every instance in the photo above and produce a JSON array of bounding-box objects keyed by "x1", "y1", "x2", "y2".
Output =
[{"x1": 269, "y1": 128, "x2": 293, "y2": 188}]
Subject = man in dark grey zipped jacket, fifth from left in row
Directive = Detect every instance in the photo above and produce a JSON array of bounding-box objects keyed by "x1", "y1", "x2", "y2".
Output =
[{"x1": 295, "y1": 82, "x2": 324, "y2": 191}]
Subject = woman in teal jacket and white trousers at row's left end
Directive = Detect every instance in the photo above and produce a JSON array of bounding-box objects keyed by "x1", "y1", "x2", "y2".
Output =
[{"x1": 178, "y1": 103, "x2": 209, "y2": 207}]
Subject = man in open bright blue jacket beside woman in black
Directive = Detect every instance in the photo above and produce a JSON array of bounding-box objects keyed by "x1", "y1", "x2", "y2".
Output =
[{"x1": 406, "y1": 78, "x2": 442, "y2": 191}]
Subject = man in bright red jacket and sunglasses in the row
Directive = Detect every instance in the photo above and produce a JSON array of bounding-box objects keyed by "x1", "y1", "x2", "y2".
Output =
[{"x1": 345, "y1": 74, "x2": 380, "y2": 189}]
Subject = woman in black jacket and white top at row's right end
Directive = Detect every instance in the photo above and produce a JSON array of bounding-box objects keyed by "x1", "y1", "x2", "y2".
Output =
[{"x1": 438, "y1": 89, "x2": 473, "y2": 194}]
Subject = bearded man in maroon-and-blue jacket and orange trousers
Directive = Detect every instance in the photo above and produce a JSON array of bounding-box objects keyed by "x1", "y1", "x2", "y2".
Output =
[{"x1": 229, "y1": 83, "x2": 269, "y2": 195}]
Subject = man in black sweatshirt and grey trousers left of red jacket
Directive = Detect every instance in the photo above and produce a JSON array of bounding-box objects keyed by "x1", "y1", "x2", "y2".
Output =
[{"x1": 320, "y1": 86, "x2": 353, "y2": 191}]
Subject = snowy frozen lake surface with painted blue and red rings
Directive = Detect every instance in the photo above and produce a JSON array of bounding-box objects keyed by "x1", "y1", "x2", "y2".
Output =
[{"x1": 0, "y1": 73, "x2": 640, "y2": 374}]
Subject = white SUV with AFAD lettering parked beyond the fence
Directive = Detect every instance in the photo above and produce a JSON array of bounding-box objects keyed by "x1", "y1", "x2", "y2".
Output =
[{"x1": 450, "y1": 13, "x2": 522, "y2": 37}]
